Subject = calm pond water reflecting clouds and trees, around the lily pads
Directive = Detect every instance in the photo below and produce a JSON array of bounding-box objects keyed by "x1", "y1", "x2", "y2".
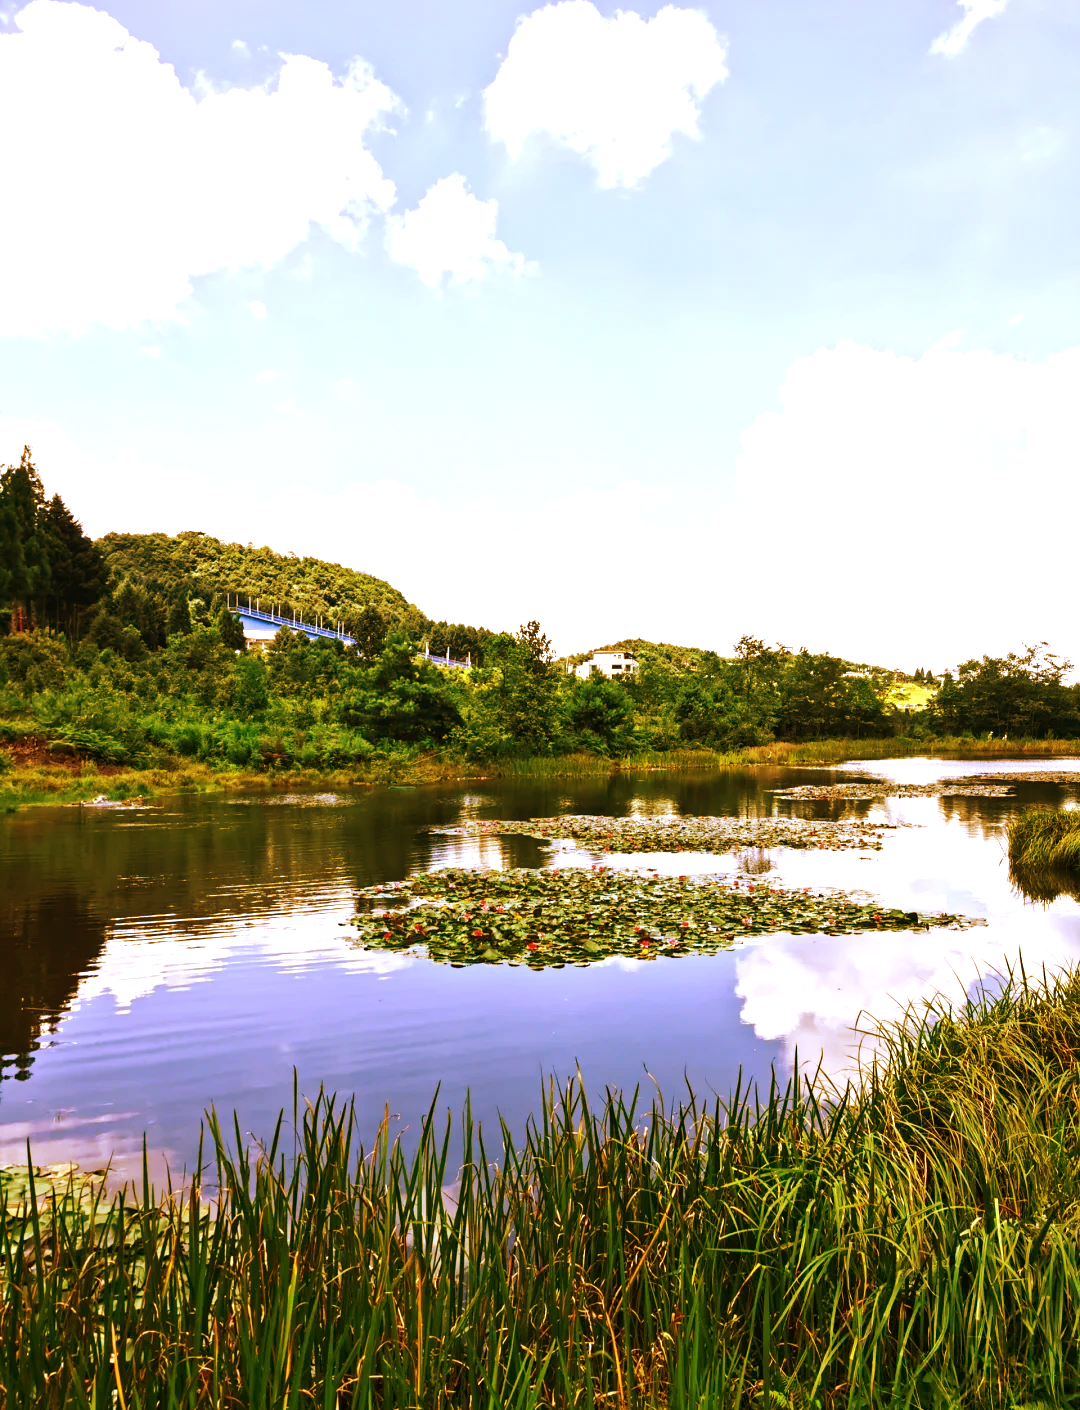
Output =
[{"x1": 0, "y1": 759, "x2": 1080, "y2": 1176}]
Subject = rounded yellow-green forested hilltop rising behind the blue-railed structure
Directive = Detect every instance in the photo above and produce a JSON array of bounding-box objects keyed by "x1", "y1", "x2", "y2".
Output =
[{"x1": 97, "y1": 530, "x2": 420, "y2": 623}]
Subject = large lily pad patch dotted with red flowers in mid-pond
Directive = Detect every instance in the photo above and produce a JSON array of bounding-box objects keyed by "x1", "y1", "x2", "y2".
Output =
[{"x1": 348, "y1": 867, "x2": 980, "y2": 969}]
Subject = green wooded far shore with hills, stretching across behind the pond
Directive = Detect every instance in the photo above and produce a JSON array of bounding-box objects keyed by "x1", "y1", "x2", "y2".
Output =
[{"x1": 0, "y1": 451, "x2": 1080, "y2": 767}]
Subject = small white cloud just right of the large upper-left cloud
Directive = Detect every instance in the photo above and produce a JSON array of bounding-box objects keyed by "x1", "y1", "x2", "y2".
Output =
[{"x1": 386, "y1": 172, "x2": 526, "y2": 289}]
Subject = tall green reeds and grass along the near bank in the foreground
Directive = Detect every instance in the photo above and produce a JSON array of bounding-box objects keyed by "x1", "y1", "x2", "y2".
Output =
[{"x1": 0, "y1": 977, "x2": 1080, "y2": 1410}]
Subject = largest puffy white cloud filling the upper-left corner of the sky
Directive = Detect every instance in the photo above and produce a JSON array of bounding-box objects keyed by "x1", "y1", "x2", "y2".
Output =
[{"x1": 0, "y1": 0, "x2": 398, "y2": 336}]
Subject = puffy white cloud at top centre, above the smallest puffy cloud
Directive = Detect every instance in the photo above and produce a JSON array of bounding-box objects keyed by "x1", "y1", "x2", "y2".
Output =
[{"x1": 484, "y1": 0, "x2": 728, "y2": 188}]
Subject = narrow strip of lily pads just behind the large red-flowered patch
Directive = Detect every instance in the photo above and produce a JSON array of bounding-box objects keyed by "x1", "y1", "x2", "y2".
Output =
[{"x1": 431, "y1": 815, "x2": 890, "y2": 853}]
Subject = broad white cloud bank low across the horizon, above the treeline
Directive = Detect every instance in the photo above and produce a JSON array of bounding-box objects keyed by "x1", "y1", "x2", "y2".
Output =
[{"x1": 12, "y1": 343, "x2": 1080, "y2": 670}]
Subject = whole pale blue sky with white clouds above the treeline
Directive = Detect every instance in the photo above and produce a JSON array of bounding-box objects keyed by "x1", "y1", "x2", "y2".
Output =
[{"x1": 0, "y1": 0, "x2": 1080, "y2": 671}]
